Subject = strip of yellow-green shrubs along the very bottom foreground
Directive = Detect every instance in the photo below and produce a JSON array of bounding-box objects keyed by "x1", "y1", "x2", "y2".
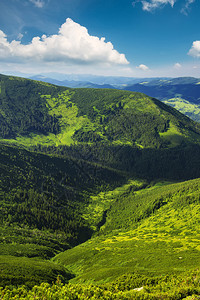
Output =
[{"x1": 0, "y1": 270, "x2": 200, "y2": 300}]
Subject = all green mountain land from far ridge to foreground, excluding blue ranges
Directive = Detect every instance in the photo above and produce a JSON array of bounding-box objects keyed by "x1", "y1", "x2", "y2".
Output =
[{"x1": 0, "y1": 75, "x2": 200, "y2": 299}]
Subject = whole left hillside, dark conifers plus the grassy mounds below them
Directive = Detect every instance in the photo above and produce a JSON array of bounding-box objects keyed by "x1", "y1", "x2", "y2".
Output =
[{"x1": 0, "y1": 144, "x2": 126, "y2": 286}]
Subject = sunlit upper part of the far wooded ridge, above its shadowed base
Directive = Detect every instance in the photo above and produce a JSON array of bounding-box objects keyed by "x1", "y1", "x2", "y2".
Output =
[{"x1": 0, "y1": 75, "x2": 199, "y2": 148}]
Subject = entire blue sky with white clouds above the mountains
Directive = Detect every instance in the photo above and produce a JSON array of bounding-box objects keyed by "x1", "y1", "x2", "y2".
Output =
[{"x1": 0, "y1": 0, "x2": 200, "y2": 77}]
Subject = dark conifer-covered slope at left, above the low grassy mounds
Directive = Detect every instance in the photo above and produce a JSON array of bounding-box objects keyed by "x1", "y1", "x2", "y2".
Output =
[{"x1": 0, "y1": 145, "x2": 126, "y2": 243}]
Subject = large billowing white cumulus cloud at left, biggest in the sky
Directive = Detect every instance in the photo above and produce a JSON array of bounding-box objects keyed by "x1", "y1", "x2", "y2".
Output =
[{"x1": 0, "y1": 18, "x2": 129, "y2": 65}]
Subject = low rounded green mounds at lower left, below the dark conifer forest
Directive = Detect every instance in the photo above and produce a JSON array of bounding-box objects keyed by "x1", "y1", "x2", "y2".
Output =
[{"x1": 0, "y1": 225, "x2": 74, "y2": 287}]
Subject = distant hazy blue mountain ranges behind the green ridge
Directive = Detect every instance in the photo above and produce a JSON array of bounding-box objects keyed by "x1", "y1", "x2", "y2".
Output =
[{"x1": 25, "y1": 73, "x2": 200, "y2": 122}]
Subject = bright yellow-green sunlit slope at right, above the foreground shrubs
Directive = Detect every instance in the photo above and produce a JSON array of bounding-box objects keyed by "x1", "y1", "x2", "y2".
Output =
[{"x1": 56, "y1": 179, "x2": 200, "y2": 282}]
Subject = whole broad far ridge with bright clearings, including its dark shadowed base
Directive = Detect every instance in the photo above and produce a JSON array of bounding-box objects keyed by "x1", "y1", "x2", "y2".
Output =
[{"x1": 0, "y1": 75, "x2": 200, "y2": 184}]
